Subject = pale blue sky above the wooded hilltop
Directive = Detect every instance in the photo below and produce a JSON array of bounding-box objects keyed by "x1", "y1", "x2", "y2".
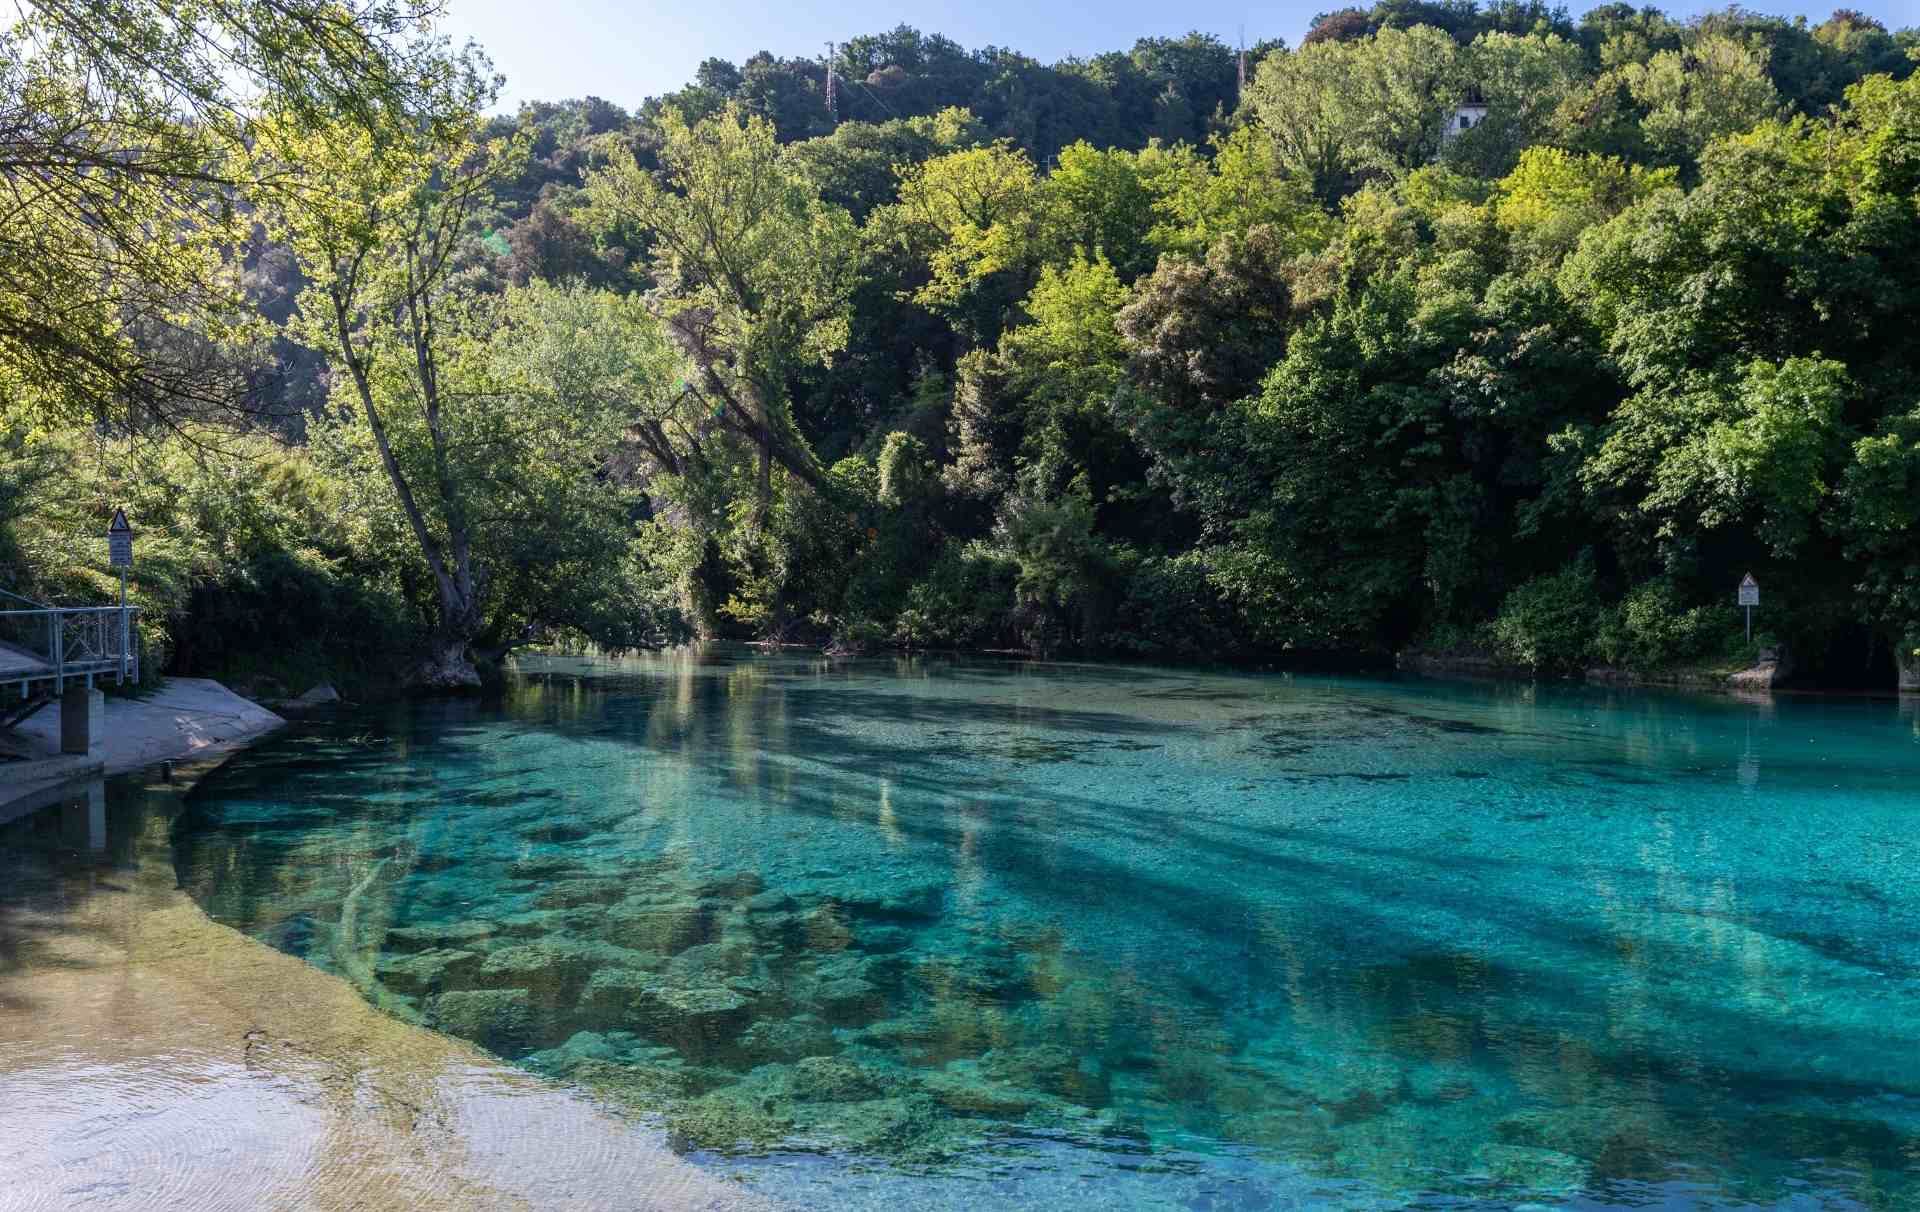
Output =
[{"x1": 444, "y1": 0, "x2": 1920, "y2": 109}]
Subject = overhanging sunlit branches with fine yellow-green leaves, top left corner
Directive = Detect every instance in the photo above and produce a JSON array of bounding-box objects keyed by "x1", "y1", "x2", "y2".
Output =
[{"x1": 0, "y1": 0, "x2": 464, "y2": 426}]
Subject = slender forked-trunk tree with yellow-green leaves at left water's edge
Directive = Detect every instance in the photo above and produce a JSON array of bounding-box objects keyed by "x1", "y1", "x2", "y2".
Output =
[{"x1": 257, "y1": 60, "x2": 526, "y2": 688}]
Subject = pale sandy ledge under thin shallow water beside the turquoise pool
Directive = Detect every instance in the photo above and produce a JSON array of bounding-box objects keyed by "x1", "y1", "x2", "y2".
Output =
[{"x1": 0, "y1": 760, "x2": 768, "y2": 1210}]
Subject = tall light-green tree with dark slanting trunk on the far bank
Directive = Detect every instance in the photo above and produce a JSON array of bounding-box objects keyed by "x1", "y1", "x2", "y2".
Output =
[{"x1": 588, "y1": 104, "x2": 862, "y2": 634}]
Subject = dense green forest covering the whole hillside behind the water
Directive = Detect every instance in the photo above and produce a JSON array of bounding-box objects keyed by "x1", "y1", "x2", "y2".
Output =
[{"x1": 0, "y1": 0, "x2": 1920, "y2": 686}]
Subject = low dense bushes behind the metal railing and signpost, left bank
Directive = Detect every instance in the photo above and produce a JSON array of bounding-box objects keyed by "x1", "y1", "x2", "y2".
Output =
[{"x1": 0, "y1": 430, "x2": 415, "y2": 693}]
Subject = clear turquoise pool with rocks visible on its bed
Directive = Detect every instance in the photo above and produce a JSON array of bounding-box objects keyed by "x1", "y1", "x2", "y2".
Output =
[{"x1": 175, "y1": 651, "x2": 1920, "y2": 1210}]
